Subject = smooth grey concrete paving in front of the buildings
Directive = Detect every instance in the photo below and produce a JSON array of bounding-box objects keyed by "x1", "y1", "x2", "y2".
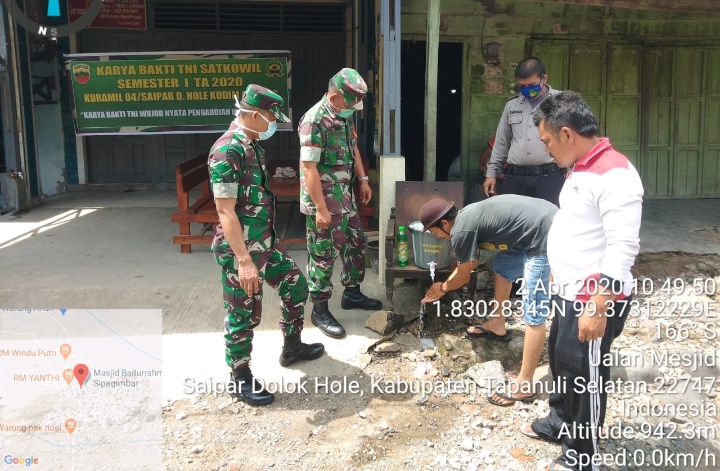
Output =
[{"x1": 0, "y1": 190, "x2": 720, "y2": 398}]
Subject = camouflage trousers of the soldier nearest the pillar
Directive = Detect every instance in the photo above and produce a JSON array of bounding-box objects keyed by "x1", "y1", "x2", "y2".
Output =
[{"x1": 306, "y1": 213, "x2": 367, "y2": 303}]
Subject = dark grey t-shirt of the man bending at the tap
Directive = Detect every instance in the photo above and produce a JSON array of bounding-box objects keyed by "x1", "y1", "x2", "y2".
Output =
[{"x1": 450, "y1": 195, "x2": 558, "y2": 263}]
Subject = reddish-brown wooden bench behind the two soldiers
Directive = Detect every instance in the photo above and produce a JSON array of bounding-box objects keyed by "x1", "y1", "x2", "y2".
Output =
[{"x1": 172, "y1": 154, "x2": 375, "y2": 253}]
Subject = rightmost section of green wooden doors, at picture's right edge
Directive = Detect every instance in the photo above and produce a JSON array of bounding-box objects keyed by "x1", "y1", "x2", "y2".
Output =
[{"x1": 641, "y1": 46, "x2": 720, "y2": 198}]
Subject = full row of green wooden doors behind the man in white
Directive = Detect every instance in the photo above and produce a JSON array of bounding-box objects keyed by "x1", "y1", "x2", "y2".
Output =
[{"x1": 532, "y1": 40, "x2": 720, "y2": 198}]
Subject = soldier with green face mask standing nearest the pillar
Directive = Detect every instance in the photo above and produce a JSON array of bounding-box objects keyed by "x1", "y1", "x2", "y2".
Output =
[{"x1": 298, "y1": 68, "x2": 382, "y2": 338}]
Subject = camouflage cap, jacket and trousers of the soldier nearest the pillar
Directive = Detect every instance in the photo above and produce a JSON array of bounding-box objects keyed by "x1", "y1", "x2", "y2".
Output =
[{"x1": 298, "y1": 68, "x2": 367, "y2": 303}]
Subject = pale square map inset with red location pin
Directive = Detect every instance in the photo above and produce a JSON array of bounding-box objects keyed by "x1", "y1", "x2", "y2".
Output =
[{"x1": 0, "y1": 309, "x2": 162, "y2": 471}]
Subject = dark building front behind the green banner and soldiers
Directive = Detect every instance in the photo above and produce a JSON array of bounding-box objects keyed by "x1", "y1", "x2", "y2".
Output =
[{"x1": 0, "y1": 0, "x2": 374, "y2": 206}]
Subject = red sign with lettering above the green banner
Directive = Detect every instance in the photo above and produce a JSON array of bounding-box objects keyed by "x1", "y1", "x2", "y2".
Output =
[{"x1": 68, "y1": 0, "x2": 147, "y2": 29}]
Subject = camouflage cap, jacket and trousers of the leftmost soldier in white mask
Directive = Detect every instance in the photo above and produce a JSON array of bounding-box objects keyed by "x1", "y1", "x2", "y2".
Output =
[{"x1": 208, "y1": 85, "x2": 307, "y2": 368}]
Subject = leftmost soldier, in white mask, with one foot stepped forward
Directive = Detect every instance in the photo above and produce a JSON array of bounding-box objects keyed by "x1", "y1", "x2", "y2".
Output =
[{"x1": 208, "y1": 85, "x2": 324, "y2": 405}]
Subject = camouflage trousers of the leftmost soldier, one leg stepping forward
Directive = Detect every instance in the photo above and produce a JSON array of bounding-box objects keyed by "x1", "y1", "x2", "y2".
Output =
[{"x1": 215, "y1": 242, "x2": 308, "y2": 368}]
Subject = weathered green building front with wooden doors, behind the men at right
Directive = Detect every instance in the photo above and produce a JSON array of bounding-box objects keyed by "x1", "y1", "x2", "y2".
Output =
[{"x1": 402, "y1": 0, "x2": 720, "y2": 198}]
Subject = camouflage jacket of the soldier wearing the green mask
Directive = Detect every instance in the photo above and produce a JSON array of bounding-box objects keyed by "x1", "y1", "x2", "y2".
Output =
[{"x1": 298, "y1": 96, "x2": 357, "y2": 215}]
